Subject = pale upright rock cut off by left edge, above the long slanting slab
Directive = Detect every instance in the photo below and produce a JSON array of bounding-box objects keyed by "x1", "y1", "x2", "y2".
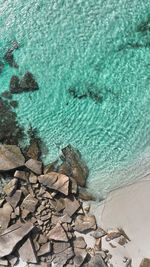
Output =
[{"x1": 0, "y1": 203, "x2": 13, "y2": 233}]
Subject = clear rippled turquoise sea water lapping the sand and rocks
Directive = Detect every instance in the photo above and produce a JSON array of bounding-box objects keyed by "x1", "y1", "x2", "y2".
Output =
[{"x1": 0, "y1": 0, "x2": 150, "y2": 195}]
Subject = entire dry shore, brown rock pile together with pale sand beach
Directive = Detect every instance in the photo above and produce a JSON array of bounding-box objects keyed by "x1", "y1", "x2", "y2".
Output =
[{"x1": 0, "y1": 143, "x2": 150, "y2": 267}]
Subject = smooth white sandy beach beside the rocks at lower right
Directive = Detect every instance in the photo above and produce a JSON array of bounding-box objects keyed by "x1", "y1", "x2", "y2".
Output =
[{"x1": 88, "y1": 177, "x2": 150, "y2": 267}]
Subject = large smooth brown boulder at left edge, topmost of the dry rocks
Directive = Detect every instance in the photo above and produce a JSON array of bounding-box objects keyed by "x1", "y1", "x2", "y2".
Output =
[{"x1": 0, "y1": 145, "x2": 25, "y2": 171}]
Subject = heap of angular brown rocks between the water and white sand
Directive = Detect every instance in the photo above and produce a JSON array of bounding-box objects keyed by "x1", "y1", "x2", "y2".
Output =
[{"x1": 0, "y1": 145, "x2": 132, "y2": 267}]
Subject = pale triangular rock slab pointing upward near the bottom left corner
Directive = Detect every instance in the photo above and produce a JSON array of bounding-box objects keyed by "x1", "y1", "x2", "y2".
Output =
[{"x1": 18, "y1": 237, "x2": 37, "y2": 263}]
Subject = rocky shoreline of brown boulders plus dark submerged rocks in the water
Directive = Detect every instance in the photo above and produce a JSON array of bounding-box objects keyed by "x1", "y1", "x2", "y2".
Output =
[{"x1": 0, "y1": 44, "x2": 150, "y2": 267}]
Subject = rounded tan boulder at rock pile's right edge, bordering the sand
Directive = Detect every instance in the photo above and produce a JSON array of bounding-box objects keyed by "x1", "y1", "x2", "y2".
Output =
[{"x1": 74, "y1": 214, "x2": 96, "y2": 233}]
